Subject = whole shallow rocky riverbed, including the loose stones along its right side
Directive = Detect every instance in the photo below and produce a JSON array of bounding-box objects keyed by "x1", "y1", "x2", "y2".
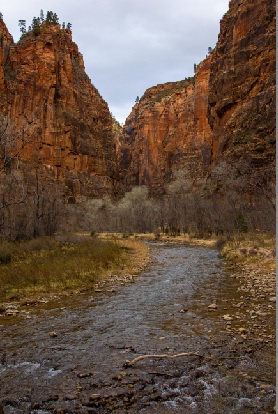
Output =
[{"x1": 0, "y1": 244, "x2": 276, "y2": 414}]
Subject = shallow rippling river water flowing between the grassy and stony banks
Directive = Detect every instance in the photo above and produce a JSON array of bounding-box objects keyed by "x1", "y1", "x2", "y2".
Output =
[{"x1": 0, "y1": 244, "x2": 273, "y2": 414}]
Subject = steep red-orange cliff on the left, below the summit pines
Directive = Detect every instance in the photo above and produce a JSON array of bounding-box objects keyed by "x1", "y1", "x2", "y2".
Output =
[{"x1": 0, "y1": 21, "x2": 116, "y2": 201}]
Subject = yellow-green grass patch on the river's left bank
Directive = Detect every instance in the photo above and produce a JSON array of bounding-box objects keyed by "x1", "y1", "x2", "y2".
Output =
[{"x1": 0, "y1": 235, "x2": 147, "y2": 300}]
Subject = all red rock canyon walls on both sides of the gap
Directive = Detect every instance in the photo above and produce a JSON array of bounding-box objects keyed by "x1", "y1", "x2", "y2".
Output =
[{"x1": 0, "y1": 0, "x2": 275, "y2": 206}]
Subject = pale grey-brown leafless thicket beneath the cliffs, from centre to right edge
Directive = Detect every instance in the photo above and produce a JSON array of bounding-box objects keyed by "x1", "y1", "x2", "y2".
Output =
[{"x1": 69, "y1": 163, "x2": 275, "y2": 238}]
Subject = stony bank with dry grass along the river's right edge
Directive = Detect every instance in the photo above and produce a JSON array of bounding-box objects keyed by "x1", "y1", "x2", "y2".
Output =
[{"x1": 218, "y1": 234, "x2": 276, "y2": 350}]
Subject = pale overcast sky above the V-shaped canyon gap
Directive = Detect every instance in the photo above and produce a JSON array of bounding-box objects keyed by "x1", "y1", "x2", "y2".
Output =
[{"x1": 0, "y1": 0, "x2": 229, "y2": 122}]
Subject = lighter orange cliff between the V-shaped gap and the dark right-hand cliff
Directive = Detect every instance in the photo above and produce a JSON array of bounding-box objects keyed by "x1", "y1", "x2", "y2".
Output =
[{"x1": 120, "y1": 57, "x2": 212, "y2": 193}]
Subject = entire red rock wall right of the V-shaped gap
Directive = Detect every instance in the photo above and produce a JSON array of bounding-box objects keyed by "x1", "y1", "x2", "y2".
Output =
[{"x1": 120, "y1": 0, "x2": 275, "y2": 194}]
